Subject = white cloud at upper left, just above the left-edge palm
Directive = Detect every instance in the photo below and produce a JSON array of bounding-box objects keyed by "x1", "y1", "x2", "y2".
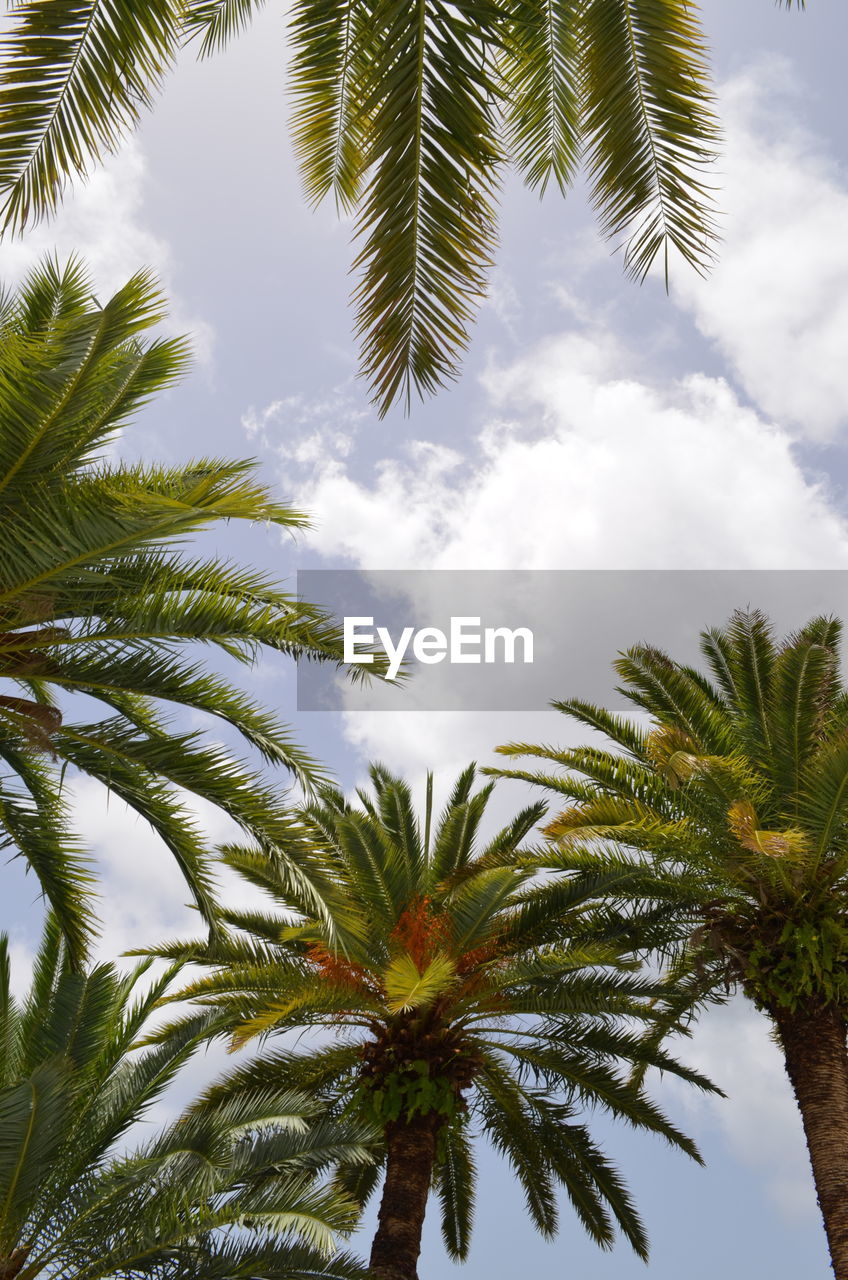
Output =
[{"x1": 0, "y1": 138, "x2": 214, "y2": 364}]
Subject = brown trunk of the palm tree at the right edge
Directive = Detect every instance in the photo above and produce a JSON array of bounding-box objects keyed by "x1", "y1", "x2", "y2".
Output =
[{"x1": 771, "y1": 1006, "x2": 848, "y2": 1280}]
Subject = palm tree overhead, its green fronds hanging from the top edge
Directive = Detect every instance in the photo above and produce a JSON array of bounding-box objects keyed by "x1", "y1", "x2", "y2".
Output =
[{"x1": 0, "y1": 0, "x2": 742, "y2": 412}]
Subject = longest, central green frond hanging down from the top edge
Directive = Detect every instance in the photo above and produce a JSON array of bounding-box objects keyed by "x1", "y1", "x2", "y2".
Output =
[{"x1": 354, "y1": 0, "x2": 502, "y2": 415}]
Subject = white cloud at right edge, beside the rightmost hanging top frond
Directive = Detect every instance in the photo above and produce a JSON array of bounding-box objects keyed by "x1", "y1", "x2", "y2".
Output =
[{"x1": 674, "y1": 58, "x2": 848, "y2": 440}]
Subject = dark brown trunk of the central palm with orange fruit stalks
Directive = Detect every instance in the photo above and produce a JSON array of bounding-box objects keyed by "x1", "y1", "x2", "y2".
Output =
[{"x1": 370, "y1": 1115, "x2": 437, "y2": 1280}]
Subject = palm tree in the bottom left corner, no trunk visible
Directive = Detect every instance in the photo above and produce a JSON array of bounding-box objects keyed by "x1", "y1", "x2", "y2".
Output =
[{"x1": 0, "y1": 918, "x2": 369, "y2": 1280}]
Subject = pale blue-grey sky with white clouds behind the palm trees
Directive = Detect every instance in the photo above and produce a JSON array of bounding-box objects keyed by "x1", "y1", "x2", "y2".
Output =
[{"x1": 0, "y1": 0, "x2": 848, "y2": 1280}]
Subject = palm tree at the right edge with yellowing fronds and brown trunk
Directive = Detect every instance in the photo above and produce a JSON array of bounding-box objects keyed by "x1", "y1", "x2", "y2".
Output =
[{"x1": 496, "y1": 612, "x2": 848, "y2": 1280}]
